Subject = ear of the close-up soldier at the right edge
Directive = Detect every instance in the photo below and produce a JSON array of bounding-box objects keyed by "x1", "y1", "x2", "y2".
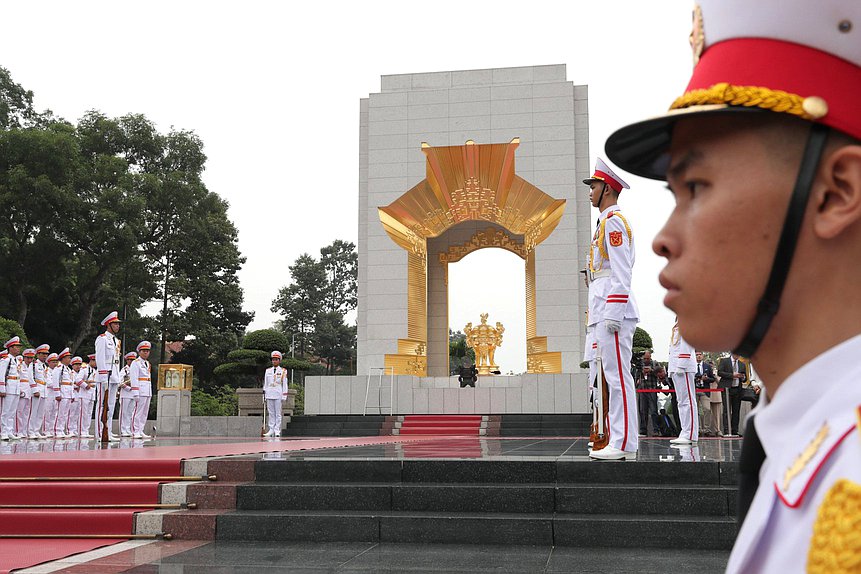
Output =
[{"x1": 812, "y1": 145, "x2": 861, "y2": 240}]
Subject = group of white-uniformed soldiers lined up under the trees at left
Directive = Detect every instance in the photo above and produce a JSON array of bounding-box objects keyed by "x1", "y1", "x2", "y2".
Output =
[{"x1": 0, "y1": 312, "x2": 152, "y2": 441}]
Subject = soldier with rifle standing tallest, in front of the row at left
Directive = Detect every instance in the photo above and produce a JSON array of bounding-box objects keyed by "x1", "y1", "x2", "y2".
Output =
[{"x1": 96, "y1": 311, "x2": 122, "y2": 441}]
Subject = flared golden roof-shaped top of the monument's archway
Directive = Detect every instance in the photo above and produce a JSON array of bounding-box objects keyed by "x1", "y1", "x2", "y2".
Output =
[{"x1": 379, "y1": 138, "x2": 565, "y2": 255}]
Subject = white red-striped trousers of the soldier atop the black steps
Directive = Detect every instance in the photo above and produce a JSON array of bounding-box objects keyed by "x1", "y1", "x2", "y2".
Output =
[{"x1": 595, "y1": 319, "x2": 640, "y2": 452}]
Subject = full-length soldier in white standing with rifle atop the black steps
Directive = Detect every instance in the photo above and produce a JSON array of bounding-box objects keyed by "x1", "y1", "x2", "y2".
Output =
[{"x1": 583, "y1": 158, "x2": 639, "y2": 460}]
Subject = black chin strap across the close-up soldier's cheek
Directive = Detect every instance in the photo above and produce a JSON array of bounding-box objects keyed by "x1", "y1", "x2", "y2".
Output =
[{"x1": 733, "y1": 124, "x2": 829, "y2": 357}]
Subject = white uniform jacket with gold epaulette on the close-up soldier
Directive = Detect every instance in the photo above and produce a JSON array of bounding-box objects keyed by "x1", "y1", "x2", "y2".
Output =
[{"x1": 727, "y1": 335, "x2": 861, "y2": 573}]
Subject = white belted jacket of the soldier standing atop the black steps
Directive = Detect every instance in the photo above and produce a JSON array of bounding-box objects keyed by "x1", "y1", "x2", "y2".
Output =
[{"x1": 589, "y1": 205, "x2": 640, "y2": 325}]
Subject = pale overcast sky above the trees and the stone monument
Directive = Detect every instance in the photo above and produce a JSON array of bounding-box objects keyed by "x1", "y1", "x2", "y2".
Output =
[{"x1": 0, "y1": 0, "x2": 691, "y2": 364}]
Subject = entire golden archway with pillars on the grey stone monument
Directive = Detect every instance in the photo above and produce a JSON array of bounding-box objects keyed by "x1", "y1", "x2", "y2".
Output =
[{"x1": 379, "y1": 138, "x2": 565, "y2": 376}]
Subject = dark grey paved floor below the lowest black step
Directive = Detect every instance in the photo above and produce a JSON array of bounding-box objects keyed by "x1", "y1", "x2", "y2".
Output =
[{"x1": 57, "y1": 542, "x2": 729, "y2": 574}]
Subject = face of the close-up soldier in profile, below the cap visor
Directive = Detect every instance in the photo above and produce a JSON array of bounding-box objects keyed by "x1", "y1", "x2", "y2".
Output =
[{"x1": 652, "y1": 116, "x2": 796, "y2": 351}]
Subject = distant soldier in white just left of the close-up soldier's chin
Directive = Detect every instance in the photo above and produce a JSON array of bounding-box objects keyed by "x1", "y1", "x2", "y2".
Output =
[{"x1": 667, "y1": 317, "x2": 700, "y2": 446}]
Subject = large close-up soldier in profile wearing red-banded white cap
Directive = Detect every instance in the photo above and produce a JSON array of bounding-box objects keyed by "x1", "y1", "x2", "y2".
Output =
[{"x1": 606, "y1": 0, "x2": 861, "y2": 574}]
